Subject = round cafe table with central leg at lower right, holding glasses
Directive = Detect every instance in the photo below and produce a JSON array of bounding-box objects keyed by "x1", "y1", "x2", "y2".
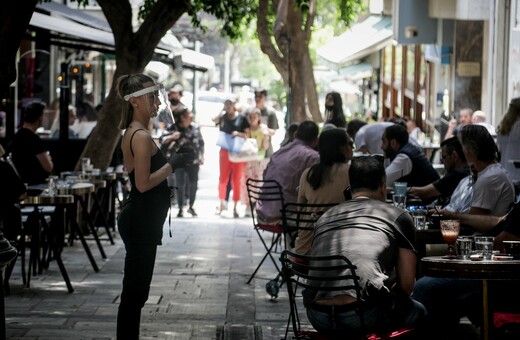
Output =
[{"x1": 421, "y1": 256, "x2": 520, "y2": 340}]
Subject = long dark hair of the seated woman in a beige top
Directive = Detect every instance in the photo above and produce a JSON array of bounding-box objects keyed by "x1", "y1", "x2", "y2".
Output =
[{"x1": 307, "y1": 129, "x2": 350, "y2": 190}]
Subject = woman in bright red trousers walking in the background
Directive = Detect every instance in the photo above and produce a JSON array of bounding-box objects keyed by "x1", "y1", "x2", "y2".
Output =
[{"x1": 213, "y1": 99, "x2": 249, "y2": 218}]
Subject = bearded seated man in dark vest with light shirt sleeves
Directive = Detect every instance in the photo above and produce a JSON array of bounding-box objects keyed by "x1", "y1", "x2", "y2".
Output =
[{"x1": 381, "y1": 124, "x2": 440, "y2": 186}]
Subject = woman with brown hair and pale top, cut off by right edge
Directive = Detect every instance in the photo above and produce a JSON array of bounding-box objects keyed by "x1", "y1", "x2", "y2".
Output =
[{"x1": 497, "y1": 98, "x2": 520, "y2": 182}]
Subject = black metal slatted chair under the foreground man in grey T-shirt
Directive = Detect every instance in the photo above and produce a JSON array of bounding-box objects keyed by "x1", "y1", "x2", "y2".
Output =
[{"x1": 280, "y1": 250, "x2": 413, "y2": 340}]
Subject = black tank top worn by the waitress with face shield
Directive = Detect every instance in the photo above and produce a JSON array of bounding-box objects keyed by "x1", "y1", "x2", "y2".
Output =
[{"x1": 118, "y1": 129, "x2": 170, "y2": 244}]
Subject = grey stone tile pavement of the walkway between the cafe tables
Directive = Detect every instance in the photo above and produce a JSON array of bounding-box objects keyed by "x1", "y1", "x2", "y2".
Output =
[{"x1": 5, "y1": 193, "x2": 300, "y2": 339}]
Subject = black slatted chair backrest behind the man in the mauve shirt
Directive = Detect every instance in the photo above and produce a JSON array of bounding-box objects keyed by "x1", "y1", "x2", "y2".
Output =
[{"x1": 246, "y1": 178, "x2": 284, "y2": 226}]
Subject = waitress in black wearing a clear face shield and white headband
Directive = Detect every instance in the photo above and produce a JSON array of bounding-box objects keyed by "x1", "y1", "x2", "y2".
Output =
[{"x1": 117, "y1": 74, "x2": 193, "y2": 340}]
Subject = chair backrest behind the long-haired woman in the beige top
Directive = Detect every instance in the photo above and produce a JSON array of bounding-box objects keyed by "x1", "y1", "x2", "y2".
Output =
[{"x1": 282, "y1": 202, "x2": 338, "y2": 235}]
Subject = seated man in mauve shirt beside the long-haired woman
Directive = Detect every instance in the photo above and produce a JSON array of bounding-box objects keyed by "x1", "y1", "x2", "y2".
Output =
[{"x1": 256, "y1": 121, "x2": 320, "y2": 223}]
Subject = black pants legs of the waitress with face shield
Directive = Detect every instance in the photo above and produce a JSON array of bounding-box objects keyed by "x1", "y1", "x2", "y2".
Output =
[{"x1": 117, "y1": 243, "x2": 157, "y2": 340}]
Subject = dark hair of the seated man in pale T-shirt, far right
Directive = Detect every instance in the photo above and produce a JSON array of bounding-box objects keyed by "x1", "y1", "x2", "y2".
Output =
[{"x1": 458, "y1": 124, "x2": 498, "y2": 161}]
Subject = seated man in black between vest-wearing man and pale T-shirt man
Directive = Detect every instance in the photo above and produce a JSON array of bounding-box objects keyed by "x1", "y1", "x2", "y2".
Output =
[{"x1": 409, "y1": 137, "x2": 470, "y2": 206}]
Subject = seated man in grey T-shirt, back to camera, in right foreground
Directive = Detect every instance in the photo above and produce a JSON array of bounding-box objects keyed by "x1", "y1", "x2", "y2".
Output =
[{"x1": 303, "y1": 156, "x2": 426, "y2": 338}]
